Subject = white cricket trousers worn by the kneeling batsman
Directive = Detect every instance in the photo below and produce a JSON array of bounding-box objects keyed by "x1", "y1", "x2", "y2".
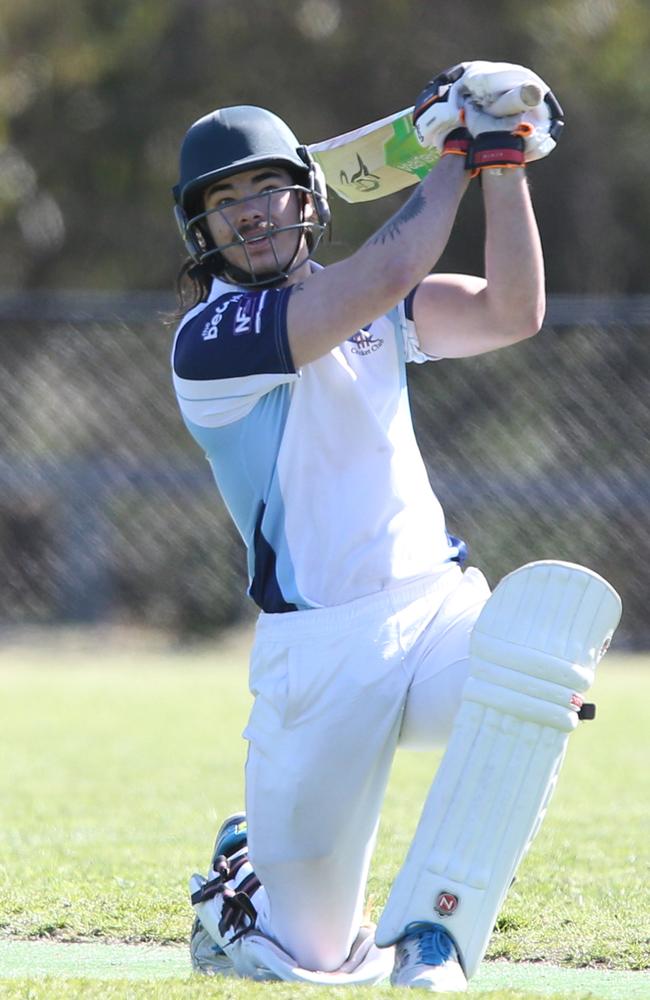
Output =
[{"x1": 244, "y1": 566, "x2": 489, "y2": 971}]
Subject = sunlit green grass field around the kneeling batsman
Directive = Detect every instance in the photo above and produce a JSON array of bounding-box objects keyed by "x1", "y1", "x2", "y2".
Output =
[{"x1": 0, "y1": 634, "x2": 650, "y2": 1000}]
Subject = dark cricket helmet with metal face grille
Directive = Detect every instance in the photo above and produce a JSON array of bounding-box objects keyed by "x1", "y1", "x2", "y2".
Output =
[{"x1": 173, "y1": 105, "x2": 330, "y2": 287}]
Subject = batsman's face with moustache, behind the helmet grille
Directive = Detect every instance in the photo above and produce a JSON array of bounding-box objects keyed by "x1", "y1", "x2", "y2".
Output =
[{"x1": 204, "y1": 166, "x2": 307, "y2": 273}]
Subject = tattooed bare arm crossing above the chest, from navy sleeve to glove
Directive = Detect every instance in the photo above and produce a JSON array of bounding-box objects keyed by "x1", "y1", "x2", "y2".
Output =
[{"x1": 287, "y1": 156, "x2": 468, "y2": 367}]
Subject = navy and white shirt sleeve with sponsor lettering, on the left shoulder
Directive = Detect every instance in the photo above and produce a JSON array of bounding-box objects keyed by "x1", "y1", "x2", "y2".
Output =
[{"x1": 172, "y1": 288, "x2": 298, "y2": 427}]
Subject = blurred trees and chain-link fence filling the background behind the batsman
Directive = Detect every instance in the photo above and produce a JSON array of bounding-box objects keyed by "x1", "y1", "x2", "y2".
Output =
[{"x1": 0, "y1": 0, "x2": 650, "y2": 648}]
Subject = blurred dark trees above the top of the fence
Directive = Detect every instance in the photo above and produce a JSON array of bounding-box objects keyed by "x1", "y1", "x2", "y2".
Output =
[{"x1": 0, "y1": 0, "x2": 650, "y2": 293}]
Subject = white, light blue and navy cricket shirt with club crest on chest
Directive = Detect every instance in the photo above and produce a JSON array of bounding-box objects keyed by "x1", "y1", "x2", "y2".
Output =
[{"x1": 172, "y1": 279, "x2": 462, "y2": 613}]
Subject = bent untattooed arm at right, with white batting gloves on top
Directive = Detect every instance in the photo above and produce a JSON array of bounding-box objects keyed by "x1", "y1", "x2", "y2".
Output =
[{"x1": 394, "y1": 62, "x2": 564, "y2": 357}]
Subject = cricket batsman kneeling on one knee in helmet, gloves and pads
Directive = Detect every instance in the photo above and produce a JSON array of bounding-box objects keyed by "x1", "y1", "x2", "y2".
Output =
[{"x1": 167, "y1": 61, "x2": 621, "y2": 993}]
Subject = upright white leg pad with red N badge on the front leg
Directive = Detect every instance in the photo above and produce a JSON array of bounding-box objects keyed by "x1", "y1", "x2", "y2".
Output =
[{"x1": 375, "y1": 561, "x2": 621, "y2": 979}]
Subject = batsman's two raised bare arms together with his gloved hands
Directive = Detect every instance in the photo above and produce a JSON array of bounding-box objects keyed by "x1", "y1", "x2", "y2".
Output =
[{"x1": 287, "y1": 56, "x2": 563, "y2": 367}]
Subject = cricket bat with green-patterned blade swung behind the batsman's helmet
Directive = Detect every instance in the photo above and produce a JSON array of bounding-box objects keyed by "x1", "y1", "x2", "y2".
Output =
[{"x1": 308, "y1": 84, "x2": 543, "y2": 204}]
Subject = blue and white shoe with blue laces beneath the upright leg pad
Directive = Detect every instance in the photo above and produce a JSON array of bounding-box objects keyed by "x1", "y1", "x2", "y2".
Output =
[{"x1": 390, "y1": 922, "x2": 467, "y2": 993}]
